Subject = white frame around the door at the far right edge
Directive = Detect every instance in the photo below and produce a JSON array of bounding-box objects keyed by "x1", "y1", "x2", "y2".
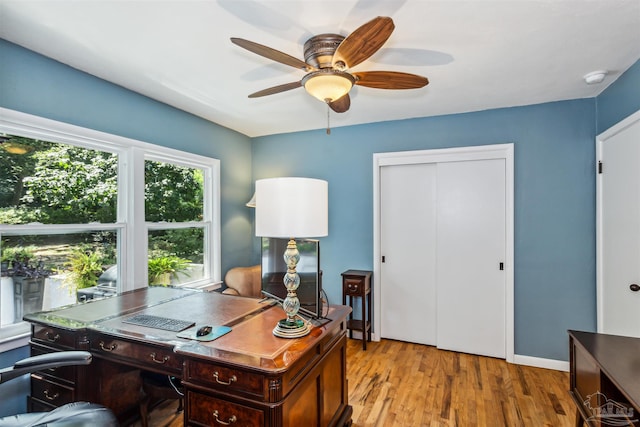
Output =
[{"x1": 596, "y1": 110, "x2": 640, "y2": 333}]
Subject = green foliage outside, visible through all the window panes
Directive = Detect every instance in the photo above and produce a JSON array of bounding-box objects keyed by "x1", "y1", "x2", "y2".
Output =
[{"x1": 0, "y1": 136, "x2": 204, "y2": 289}]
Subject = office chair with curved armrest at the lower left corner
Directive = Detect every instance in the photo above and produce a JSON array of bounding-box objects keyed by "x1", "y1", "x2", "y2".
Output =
[{"x1": 0, "y1": 351, "x2": 118, "y2": 427}]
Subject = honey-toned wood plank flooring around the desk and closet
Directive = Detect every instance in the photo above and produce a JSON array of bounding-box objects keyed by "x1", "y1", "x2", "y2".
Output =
[{"x1": 136, "y1": 340, "x2": 575, "y2": 427}]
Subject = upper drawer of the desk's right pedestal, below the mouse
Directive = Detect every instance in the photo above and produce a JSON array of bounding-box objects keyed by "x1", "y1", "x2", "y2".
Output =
[{"x1": 185, "y1": 360, "x2": 266, "y2": 400}]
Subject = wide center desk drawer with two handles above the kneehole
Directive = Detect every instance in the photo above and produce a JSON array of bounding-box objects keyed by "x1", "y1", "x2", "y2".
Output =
[{"x1": 91, "y1": 335, "x2": 183, "y2": 376}]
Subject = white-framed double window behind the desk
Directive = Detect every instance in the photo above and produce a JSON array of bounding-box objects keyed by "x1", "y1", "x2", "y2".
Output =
[{"x1": 0, "y1": 109, "x2": 220, "y2": 348}]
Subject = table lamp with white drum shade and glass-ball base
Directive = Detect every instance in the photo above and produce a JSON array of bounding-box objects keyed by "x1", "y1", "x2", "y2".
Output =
[{"x1": 256, "y1": 177, "x2": 329, "y2": 338}]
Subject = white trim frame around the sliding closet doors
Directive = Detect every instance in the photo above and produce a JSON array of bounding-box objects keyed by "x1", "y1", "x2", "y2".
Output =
[{"x1": 371, "y1": 143, "x2": 515, "y2": 363}]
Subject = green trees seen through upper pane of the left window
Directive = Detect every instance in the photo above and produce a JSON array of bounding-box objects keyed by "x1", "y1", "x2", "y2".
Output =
[{"x1": 0, "y1": 137, "x2": 118, "y2": 224}]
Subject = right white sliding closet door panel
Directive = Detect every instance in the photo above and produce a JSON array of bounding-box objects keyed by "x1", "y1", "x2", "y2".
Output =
[{"x1": 436, "y1": 159, "x2": 506, "y2": 358}]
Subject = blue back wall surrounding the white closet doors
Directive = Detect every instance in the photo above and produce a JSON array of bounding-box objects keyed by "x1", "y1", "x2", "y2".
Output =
[{"x1": 253, "y1": 99, "x2": 596, "y2": 360}]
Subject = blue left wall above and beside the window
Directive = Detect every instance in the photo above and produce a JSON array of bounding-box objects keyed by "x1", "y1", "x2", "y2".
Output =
[{"x1": 0, "y1": 39, "x2": 252, "y2": 273}]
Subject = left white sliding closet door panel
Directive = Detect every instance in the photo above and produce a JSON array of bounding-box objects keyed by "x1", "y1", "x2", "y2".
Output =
[{"x1": 380, "y1": 164, "x2": 436, "y2": 345}]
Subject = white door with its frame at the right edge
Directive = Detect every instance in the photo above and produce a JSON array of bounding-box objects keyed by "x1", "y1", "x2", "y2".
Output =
[{"x1": 598, "y1": 112, "x2": 640, "y2": 337}]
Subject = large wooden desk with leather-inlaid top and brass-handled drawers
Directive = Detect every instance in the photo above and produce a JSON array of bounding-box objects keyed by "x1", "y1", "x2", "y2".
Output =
[{"x1": 25, "y1": 287, "x2": 352, "y2": 426}]
